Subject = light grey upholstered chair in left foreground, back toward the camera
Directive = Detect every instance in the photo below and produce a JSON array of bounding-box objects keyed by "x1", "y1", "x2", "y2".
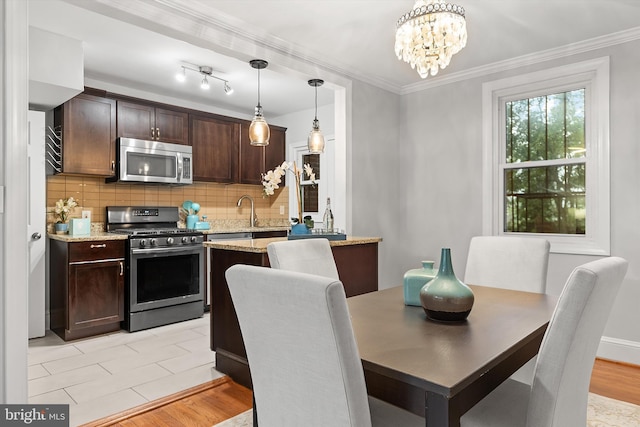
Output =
[{"x1": 226, "y1": 264, "x2": 425, "y2": 427}]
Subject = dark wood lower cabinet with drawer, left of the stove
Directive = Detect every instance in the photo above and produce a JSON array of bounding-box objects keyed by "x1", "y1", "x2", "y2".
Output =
[{"x1": 50, "y1": 240, "x2": 125, "y2": 340}]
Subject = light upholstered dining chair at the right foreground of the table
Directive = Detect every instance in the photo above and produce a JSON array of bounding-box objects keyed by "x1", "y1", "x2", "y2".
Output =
[{"x1": 461, "y1": 257, "x2": 628, "y2": 427}]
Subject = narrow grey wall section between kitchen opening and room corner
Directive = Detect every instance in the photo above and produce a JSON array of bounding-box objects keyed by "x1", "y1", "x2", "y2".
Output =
[{"x1": 347, "y1": 81, "x2": 407, "y2": 289}]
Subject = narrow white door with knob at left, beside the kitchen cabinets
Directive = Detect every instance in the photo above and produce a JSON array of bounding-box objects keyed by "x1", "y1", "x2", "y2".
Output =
[{"x1": 27, "y1": 111, "x2": 47, "y2": 338}]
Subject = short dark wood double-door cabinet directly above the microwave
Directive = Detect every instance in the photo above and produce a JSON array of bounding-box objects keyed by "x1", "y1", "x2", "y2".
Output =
[{"x1": 118, "y1": 100, "x2": 189, "y2": 145}]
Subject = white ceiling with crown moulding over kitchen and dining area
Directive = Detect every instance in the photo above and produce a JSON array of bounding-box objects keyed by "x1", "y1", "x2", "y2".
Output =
[{"x1": 29, "y1": 0, "x2": 640, "y2": 120}]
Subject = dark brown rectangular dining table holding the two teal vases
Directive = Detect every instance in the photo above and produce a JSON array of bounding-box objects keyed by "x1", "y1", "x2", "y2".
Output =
[{"x1": 347, "y1": 285, "x2": 557, "y2": 427}]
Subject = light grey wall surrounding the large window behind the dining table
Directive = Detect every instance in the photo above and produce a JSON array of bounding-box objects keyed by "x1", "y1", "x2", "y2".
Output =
[{"x1": 398, "y1": 37, "x2": 640, "y2": 364}]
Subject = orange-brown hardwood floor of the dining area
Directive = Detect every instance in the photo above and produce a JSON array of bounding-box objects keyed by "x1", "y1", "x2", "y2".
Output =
[{"x1": 82, "y1": 359, "x2": 640, "y2": 427}]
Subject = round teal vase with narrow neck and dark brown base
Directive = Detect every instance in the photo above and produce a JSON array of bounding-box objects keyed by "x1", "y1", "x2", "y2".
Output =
[{"x1": 420, "y1": 248, "x2": 474, "y2": 322}]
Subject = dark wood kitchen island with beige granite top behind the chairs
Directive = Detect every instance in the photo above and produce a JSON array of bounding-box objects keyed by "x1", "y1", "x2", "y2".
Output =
[{"x1": 204, "y1": 237, "x2": 382, "y2": 387}]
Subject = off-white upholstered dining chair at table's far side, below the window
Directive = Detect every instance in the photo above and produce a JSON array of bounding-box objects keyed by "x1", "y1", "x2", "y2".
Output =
[{"x1": 464, "y1": 236, "x2": 550, "y2": 384}]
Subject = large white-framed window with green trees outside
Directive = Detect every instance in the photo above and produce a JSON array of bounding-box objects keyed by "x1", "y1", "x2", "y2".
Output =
[{"x1": 483, "y1": 58, "x2": 609, "y2": 255}]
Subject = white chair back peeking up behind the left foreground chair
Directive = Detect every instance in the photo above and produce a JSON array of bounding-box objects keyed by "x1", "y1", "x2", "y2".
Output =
[{"x1": 267, "y1": 238, "x2": 339, "y2": 279}]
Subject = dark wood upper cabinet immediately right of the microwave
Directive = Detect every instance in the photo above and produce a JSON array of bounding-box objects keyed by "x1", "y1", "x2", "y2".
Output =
[{"x1": 189, "y1": 114, "x2": 240, "y2": 183}]
